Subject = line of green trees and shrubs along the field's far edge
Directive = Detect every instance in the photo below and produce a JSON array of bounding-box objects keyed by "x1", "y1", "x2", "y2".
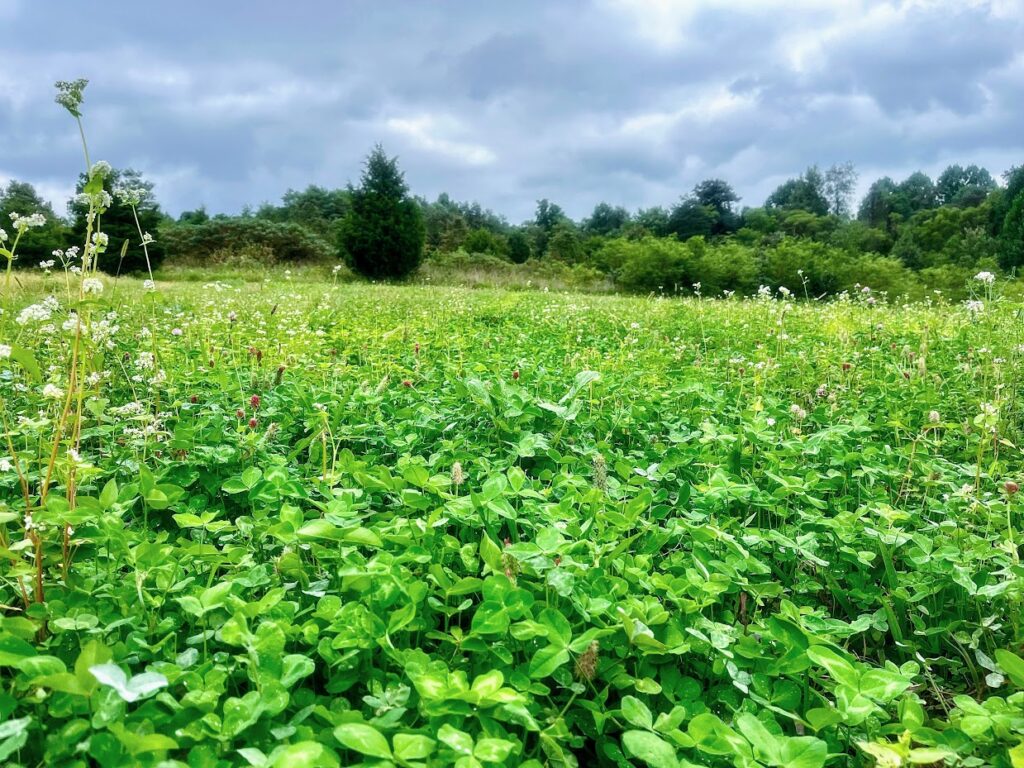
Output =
[{"x1": 0, "y1": 145, "x2": 1024, "y2": 295}]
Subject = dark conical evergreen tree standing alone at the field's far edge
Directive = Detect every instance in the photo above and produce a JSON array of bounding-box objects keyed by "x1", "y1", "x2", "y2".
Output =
[{"x1": 339, "y1": 144, "x2": 424, "y2": 278}]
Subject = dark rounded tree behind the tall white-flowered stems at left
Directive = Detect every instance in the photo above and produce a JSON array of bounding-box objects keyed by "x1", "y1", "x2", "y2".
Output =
[{"x1": 69, "y1": 168, "x2": 165, "y2": 274}]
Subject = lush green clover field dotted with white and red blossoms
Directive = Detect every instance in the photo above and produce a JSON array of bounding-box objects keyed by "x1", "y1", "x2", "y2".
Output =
[{"x1": 0, "y1": 272, "x2": 1024, "y2": 768}]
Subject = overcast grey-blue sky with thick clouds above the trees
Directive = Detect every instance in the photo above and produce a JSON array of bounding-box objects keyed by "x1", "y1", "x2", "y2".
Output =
[{"x1": 0, "y1": 0, "x2": 1024, "y2": 222}]
